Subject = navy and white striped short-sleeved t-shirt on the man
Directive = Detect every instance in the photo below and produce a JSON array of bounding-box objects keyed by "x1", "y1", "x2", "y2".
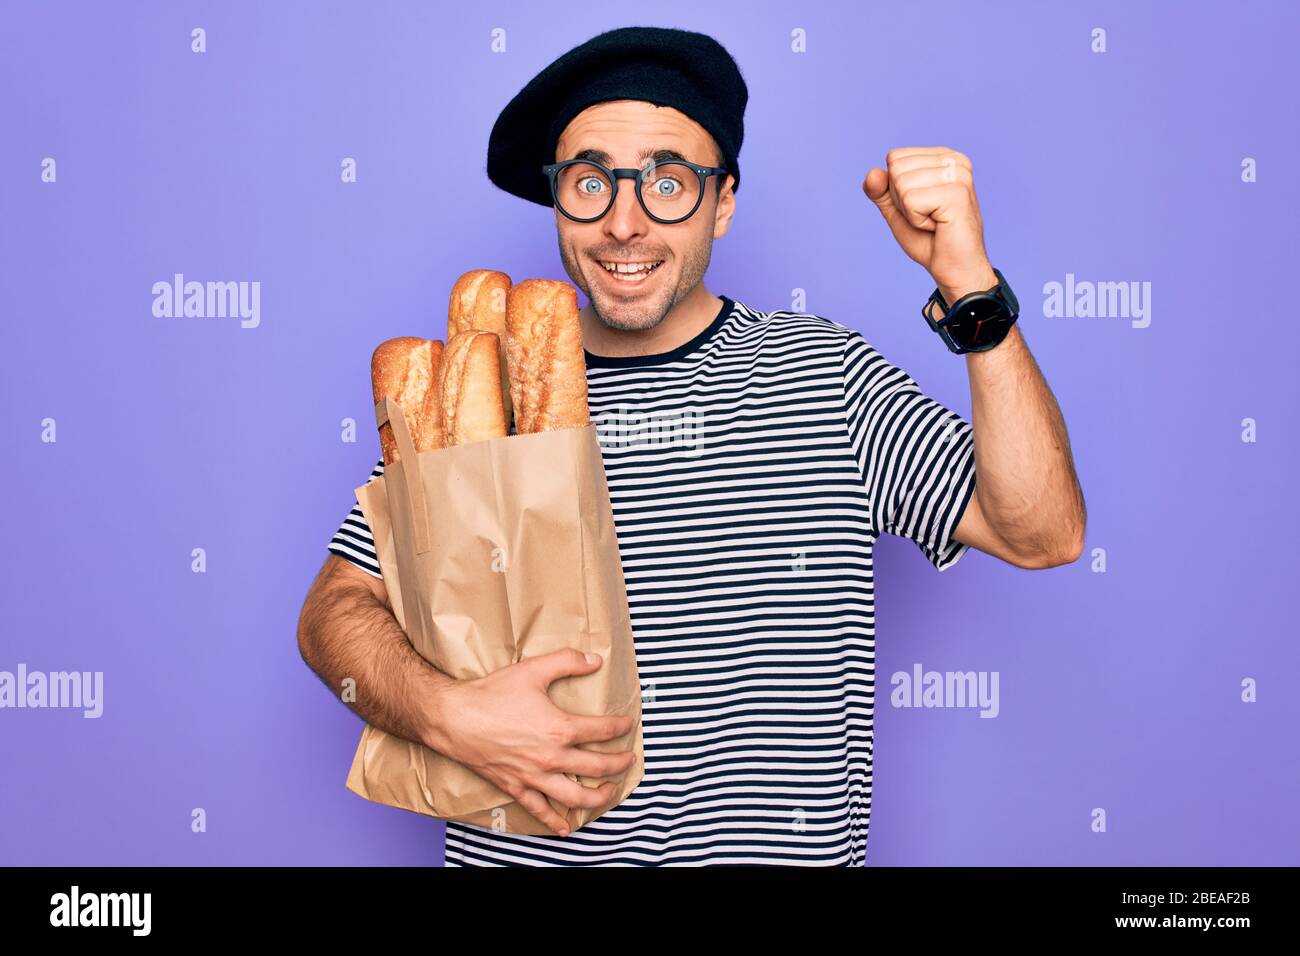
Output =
[{"x1": 329, "y1": 297, "x2": 975, "y2": 866}]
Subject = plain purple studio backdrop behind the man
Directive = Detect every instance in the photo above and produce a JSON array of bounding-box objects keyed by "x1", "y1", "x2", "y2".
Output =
[{"x1": 0, "y1": 1, "x2": 1300, "y2": 865}]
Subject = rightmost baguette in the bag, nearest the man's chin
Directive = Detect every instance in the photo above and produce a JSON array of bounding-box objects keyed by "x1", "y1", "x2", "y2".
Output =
[{"x1": 506, "y1": 278, "x2": 592, "y2": 434}]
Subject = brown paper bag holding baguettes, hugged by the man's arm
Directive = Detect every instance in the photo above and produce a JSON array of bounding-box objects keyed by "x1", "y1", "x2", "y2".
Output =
[{"x1": 347, "y1": 398, "x2": 645, "y2": 835}]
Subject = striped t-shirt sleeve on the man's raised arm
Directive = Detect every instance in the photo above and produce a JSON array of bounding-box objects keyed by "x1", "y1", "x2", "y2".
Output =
[{"x1": 844, "y1": 329, "x2": 975, "y2": 571}]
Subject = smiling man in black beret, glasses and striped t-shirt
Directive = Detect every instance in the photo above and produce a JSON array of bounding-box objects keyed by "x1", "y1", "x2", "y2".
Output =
[{"x1": 299, "y1": 27, "x2": 1084, "y2": 866}]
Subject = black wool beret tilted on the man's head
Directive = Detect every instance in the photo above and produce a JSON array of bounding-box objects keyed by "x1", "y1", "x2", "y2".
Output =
[{"x1": 488, "y1": 26, "x2": 749, "y2": 206}]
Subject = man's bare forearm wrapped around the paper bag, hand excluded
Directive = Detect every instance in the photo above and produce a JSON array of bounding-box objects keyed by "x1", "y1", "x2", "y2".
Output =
[{"x1": 298, "y1": 572, "x2": 455, "y2": 750}]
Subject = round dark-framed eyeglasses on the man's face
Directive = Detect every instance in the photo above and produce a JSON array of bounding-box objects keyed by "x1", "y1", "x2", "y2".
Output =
[{"x1": 542, "y1": 160, "x2": 727, "y2": 225}]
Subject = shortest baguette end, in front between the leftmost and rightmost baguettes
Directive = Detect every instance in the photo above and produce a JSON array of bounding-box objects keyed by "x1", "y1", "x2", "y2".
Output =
[{"x1": 438, "y1": 329, "x2": 510, "y2": 447}]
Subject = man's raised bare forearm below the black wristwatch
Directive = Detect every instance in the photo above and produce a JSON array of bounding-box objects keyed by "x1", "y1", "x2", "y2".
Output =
[{"x1": 966, "y1": 325, "x2": 1087, "y2": 561}]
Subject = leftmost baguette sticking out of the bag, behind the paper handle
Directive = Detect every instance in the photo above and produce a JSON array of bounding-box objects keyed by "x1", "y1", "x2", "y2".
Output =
[{"x1": 371, "y1": 336, "x2": 443, "y2": 466}]
